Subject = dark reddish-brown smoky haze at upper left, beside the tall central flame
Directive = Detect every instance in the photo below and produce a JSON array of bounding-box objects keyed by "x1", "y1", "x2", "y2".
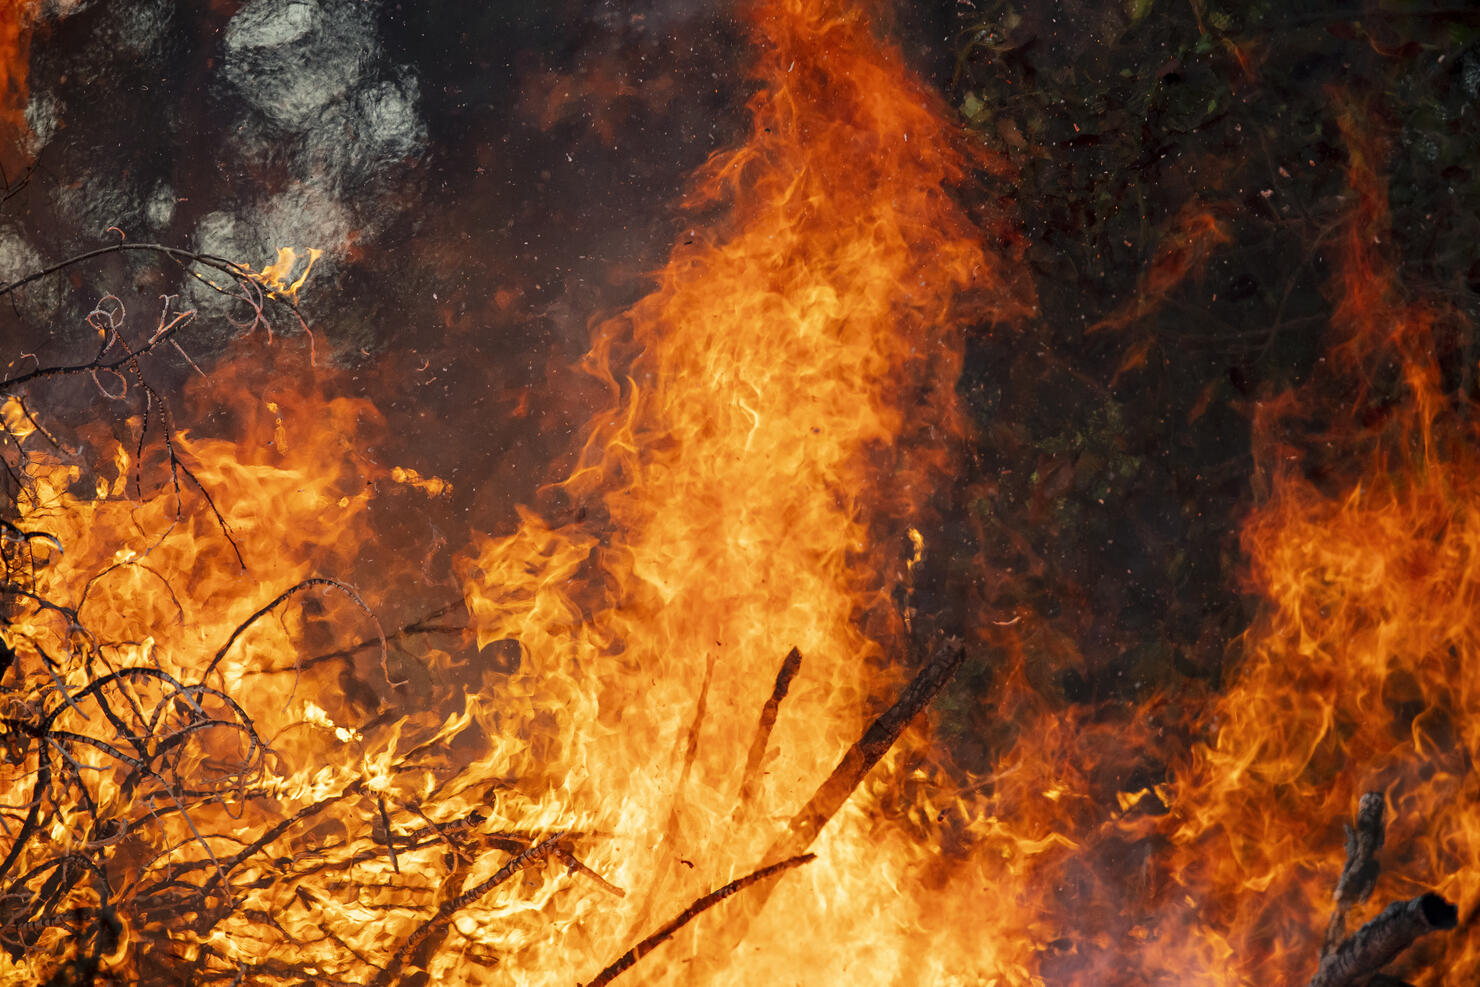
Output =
[{"x1": 0, "y1": 0, "x2": 749, "y2": 580}]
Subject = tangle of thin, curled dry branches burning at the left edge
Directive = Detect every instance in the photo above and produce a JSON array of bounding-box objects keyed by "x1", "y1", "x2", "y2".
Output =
[{"x1": 0, "y1": 270, "x2": 589, "y2": 984}]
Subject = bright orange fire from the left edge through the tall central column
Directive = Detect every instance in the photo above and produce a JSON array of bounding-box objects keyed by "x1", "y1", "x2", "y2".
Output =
[{"x1": 0, "y1": 0, "x2": 1026, "y2": 984}]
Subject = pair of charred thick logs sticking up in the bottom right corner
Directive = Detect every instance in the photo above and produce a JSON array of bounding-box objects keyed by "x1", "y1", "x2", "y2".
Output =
[{"x1": 1307, "y1": 792, "x2": 1459, "y2": 987}]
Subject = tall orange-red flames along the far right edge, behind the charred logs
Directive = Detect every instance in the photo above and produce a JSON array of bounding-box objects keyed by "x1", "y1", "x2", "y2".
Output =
[{"x1": 1169, "y1": 111, "x2": 1480, "y2": 984}]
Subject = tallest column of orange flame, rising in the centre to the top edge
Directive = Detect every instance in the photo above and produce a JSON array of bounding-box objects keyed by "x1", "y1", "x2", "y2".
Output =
[{"x1": 466, "y1": 0, "x2": 1021, "y2": 983}]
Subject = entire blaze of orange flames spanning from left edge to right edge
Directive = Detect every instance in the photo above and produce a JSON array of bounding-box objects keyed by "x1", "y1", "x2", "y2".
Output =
[{"x1": 0, "y1": 0, "x2": 1480, "y2": 987}]
